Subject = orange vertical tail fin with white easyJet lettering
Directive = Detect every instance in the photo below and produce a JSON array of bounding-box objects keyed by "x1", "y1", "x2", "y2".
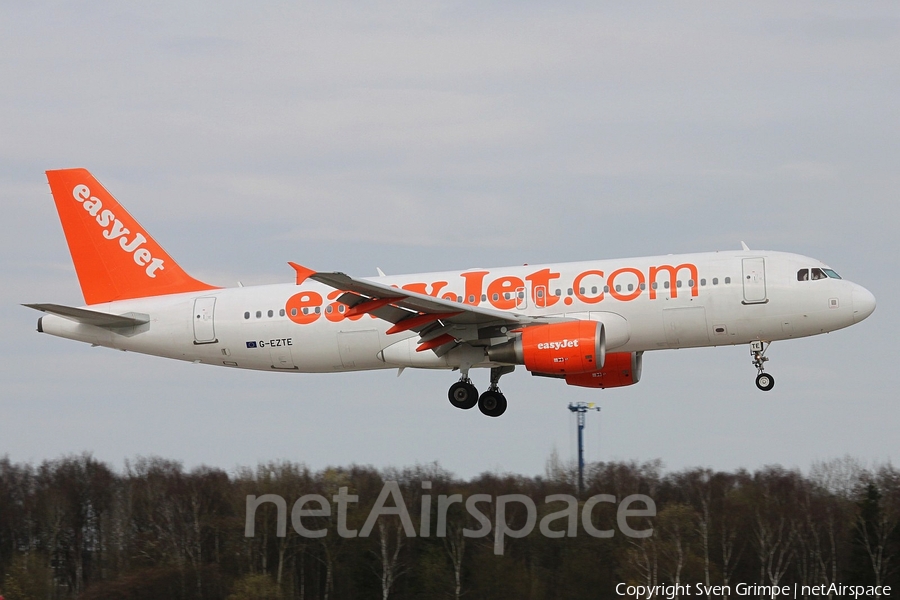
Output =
[{"x1": 47, "y1": 169, "x2": 217, "y2": 304}]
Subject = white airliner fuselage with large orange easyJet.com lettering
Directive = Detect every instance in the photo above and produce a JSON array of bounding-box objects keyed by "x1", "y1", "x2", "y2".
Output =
[{"x1": 41, "y1": 251, "x2": 874, "y2": 373}]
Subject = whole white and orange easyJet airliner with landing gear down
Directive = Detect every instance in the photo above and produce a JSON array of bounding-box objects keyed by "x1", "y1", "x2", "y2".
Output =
[{"x1": 26, "y1": 169, "x2": 875, "y2": 417}]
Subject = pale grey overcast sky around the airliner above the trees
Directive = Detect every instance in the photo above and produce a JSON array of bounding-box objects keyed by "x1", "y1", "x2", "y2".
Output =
[{"x1": 0, "y1": 1, "x2": 900, "y2": 477}]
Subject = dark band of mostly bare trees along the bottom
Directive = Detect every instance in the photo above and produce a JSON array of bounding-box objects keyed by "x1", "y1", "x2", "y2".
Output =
[{"x1": 0, "y1": 455, "x2": 900, "y2": 600}]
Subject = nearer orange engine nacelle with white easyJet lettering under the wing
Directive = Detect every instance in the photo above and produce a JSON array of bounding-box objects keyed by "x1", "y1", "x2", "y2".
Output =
[{"x1": 487, "y1": 321, "x2": 606, "y2": 376}]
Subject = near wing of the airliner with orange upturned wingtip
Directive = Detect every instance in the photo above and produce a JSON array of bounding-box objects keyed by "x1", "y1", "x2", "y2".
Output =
[{"x1": 290, "y1": 263, "x2": 568, "y2": 354}]
